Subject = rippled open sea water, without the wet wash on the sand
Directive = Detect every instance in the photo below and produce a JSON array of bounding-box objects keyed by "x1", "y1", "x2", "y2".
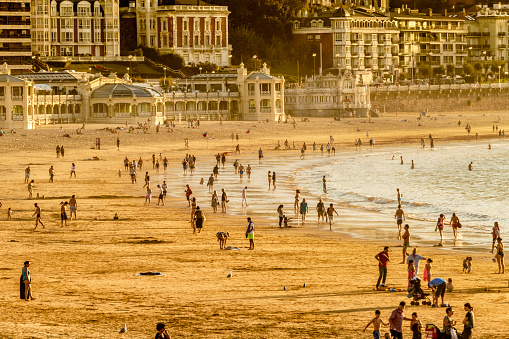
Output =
[{"x1": 293, "y1": 141, "x2": 509, "y2": 246}]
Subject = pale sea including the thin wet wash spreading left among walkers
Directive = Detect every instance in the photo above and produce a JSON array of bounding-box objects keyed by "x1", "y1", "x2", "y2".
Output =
[{"x1": 160, "y1": 140, "x2": 509, "y2": 248}]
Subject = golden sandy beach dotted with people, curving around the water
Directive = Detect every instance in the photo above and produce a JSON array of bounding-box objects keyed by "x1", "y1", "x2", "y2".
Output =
[{"x1": 0, "y1": 112, "x2": 509, "y2": 338}]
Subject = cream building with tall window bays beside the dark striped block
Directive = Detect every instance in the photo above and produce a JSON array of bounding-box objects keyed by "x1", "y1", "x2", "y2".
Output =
[{"x1": 31, "y1": 0, "x2": 120, "y2": 60}]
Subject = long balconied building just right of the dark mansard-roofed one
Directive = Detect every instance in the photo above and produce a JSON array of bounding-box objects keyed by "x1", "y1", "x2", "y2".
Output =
[{"x1": 390, "y1": 7, "x2": 468, "y2": 76}]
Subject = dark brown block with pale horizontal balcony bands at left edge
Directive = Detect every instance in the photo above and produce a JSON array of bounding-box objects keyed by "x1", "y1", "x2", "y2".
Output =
[{"x1": 0, "y1": 0, "x2": 32, "y2": 73}]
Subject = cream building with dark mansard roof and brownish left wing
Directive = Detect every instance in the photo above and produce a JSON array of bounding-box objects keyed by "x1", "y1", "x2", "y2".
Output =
[{"x1": 292, "y1": 7, "x2": 399, "y2": 78}]
